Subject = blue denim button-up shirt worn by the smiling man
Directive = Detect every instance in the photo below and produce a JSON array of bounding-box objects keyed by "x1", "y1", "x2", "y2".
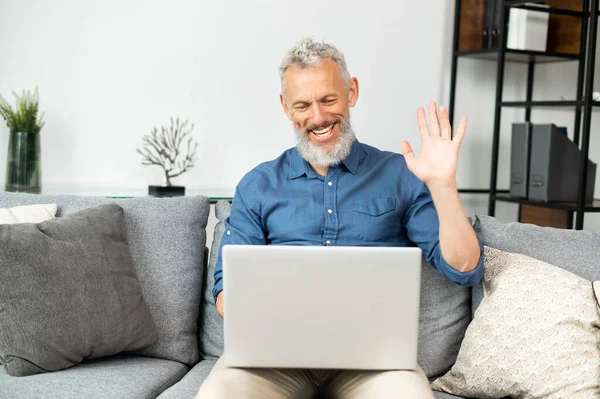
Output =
[{"x1": 213, "y1": 141, "x2": 484, "y2": 298}]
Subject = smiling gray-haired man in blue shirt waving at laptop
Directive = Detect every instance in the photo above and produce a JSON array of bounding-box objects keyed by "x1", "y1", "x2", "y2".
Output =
[{"x1": 198, "y1": 39, "x2": 483, "y2": 399}]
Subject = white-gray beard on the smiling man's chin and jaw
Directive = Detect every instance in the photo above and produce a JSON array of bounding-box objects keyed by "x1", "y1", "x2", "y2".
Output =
[{"x1": 294, "y1": 119, "x2": 356, "y2": 167}]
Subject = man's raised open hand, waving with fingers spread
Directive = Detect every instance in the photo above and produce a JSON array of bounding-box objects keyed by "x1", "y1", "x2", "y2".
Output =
[{"x1": 402, "y1": 102, "x2": 467, "y2": 185}]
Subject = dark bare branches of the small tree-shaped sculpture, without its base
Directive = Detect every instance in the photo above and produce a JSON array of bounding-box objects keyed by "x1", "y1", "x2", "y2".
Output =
[{"x1": 137, "y1": 118, "x2": 198, "y2": 187}]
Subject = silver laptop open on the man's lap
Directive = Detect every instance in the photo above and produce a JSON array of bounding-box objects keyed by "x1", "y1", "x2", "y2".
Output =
[{"x1": 222, "y1": 245, "x2": 422, "y2": 370}]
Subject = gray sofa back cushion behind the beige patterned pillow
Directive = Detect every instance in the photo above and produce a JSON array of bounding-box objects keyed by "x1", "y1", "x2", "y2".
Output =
[{"x1": 473, "y1": 215, "x2": 600, "y2": 313}]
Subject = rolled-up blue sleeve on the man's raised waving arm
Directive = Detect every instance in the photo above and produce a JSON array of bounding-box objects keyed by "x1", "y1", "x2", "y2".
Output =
[{"x1": 403, "y1": 181, "x2": 484, "y2": 287}]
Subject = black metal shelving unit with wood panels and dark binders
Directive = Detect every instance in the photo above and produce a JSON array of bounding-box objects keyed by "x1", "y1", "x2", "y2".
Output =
[{"x1": 449, "y1": 0, "x2": 600, "y2": 230}]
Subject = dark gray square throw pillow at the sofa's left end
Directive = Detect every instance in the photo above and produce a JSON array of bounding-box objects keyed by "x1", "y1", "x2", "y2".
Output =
[{"x1": 0, "y1": 204, "x2": 158, "y2": 376}]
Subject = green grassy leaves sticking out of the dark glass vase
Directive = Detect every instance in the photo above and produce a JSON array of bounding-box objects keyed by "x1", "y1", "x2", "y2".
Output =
[{"x1": 0, "y1": 87, "x2": 44, "y2": 133}]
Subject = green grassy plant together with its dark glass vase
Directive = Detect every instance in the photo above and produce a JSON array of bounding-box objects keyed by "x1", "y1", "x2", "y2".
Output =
[{"x1": 0, "y1": 87, "x2": 44, "y2": 194}]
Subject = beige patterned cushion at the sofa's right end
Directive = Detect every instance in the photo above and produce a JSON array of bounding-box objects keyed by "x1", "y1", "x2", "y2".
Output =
[{"x1": 432, "y1": 247, "x2": 600, "y2": 399}]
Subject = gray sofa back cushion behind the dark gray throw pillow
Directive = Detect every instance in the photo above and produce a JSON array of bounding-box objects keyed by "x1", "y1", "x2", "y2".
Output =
[{"x1": 0, "y1": 192, "x2": 210, "y2": 366}]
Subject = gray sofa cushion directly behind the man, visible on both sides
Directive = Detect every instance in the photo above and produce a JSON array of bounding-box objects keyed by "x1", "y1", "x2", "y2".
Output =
[{"x1": 200, "y1": 201, "x2": 471, "y2": 378}]
